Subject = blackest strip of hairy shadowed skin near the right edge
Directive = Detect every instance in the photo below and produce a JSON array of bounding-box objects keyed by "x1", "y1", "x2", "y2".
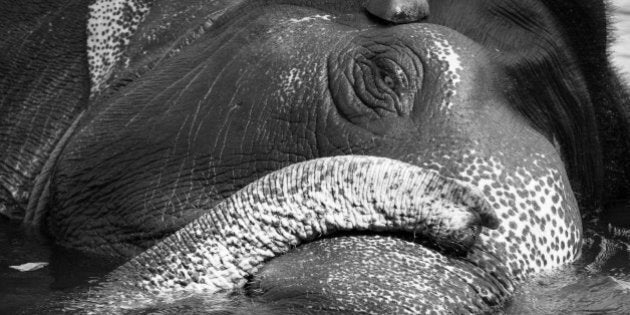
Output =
[{"x1": 542, "y1": 0, "x2": 630, "y2": 208}]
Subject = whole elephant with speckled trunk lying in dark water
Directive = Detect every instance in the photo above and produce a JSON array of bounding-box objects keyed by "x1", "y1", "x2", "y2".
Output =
[{"x1": 0, "y1": 0, "x2": 630, "y2": 314}]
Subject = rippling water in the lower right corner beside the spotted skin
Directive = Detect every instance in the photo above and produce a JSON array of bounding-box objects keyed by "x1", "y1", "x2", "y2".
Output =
[{"x1": 506, "y1": 227, "x2": 630, "y2": 314}]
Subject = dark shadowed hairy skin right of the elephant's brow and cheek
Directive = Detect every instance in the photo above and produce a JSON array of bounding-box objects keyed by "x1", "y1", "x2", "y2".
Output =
[{"x1": 447, "y1": 0, "x2": 630, "y2": 215}]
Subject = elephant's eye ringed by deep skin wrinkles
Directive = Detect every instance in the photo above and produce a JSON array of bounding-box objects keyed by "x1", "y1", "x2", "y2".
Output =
[{"x1": 328, "y1": 44, "x2": 422, "y2": 133}]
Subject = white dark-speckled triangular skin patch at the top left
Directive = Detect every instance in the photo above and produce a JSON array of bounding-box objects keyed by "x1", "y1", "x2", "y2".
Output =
[{"x1": 87, "y1": 0, "x2": 151, "y2": 94}]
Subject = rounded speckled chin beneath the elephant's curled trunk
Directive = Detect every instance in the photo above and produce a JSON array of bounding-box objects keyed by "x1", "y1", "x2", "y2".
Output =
[{"x1": 248, "y1": 235, "x2": 513, "y2": 314}]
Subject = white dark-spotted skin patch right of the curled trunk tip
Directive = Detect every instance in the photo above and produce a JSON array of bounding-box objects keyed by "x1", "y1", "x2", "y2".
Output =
[{"x1": 423, "y1": 150, "x2": 582, "y2": 280}]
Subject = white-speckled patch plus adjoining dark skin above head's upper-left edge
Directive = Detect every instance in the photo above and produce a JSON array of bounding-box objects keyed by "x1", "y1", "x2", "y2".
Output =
[{"x1": 87, "y1": 0, "x2": 243, "y2": 97}]
